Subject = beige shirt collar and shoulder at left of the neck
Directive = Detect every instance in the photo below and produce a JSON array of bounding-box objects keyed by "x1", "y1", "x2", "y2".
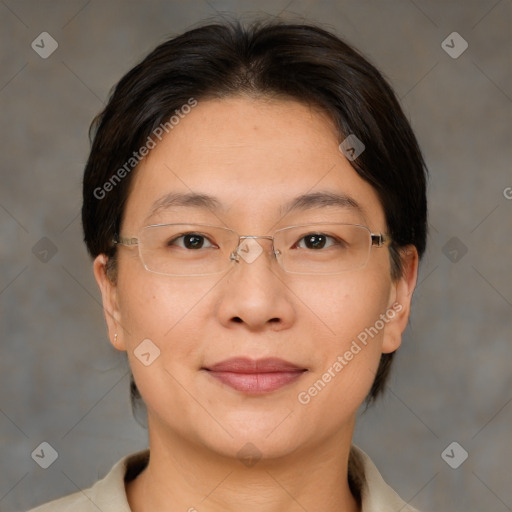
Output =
[{"x1": 29, "y1": 450, "x2": 149, "y2": 512}]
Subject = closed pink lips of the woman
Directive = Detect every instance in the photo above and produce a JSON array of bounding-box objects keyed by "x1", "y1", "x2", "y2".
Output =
[{"x1": 203, "y1": 357, "x2": 307, "y2": 395}]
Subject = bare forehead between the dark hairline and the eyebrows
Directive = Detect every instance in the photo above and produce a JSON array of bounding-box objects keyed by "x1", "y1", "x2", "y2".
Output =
[{"x1": 123, "y1": 97, "x2": 384, "y2": 227}]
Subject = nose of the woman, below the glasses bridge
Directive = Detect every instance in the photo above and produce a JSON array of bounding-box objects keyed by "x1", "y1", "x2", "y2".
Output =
[{"x1": 217, "y1": 236, "x2": 296, "y2": 331}]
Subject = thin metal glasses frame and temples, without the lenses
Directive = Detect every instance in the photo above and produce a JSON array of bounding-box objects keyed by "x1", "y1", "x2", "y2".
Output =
[{"x1": 112, "y1": 222, "x2": 392, "y2": 277}]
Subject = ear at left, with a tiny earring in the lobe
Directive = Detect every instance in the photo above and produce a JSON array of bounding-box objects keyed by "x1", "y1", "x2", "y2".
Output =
[{"x1": 93, "y1": 254, "x2": 126, "y2": 351}]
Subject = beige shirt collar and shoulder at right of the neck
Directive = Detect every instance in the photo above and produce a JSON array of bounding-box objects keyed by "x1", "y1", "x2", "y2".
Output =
[{"x1": 349, "y1": 446, "x2": 419, "y2": 512}]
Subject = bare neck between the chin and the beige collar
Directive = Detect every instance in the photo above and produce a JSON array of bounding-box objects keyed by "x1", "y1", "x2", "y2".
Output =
[{"x1": 126, "y1": 416, "x2": 360, "y2": 512}]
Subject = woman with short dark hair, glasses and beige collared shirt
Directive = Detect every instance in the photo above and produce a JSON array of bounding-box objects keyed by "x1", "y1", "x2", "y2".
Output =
[{"x1": 30, "y1": 18, "x2": 426, "y2": 512}]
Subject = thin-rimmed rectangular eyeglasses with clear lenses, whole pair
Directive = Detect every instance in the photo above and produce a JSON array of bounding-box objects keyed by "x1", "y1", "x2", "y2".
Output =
[{"x1": 113, "y1": 223, "x2": 391, "y2": 276}]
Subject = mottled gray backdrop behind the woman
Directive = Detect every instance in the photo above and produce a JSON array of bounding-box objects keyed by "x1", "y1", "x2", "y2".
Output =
[{"x1": 0, "y1": 0, "x2": 512, "y2": 512}]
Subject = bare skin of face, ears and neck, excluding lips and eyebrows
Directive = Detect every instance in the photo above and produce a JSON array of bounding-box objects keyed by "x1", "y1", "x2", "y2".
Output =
[{"x1": 94, "y1": 97, "x2": 418, "y2": 512}]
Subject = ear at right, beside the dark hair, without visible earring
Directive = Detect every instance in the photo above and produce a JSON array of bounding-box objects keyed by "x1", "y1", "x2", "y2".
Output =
[{"x1": 382, "y1": 245, "x2": 419, "y2": 354}]
